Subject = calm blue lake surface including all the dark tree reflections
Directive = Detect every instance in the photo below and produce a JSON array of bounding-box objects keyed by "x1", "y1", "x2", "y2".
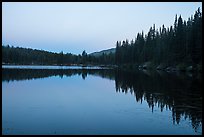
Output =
[{"x1": 2, "y1": 69, "x2": 202, "y2": 135}]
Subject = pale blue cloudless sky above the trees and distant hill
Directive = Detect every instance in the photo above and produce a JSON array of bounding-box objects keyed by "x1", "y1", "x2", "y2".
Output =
[{"x1": 2, "y1": 2, "x2": 202, "y2": 54}]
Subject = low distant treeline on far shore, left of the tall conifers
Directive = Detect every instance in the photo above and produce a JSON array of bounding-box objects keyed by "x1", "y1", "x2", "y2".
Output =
[{"x1": 2, "y1": 45, "x2": 115, "y2": 65}]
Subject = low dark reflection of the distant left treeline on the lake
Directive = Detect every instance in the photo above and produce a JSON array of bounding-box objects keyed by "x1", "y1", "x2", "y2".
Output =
[{"x1": 2, "y1": 69, "x2": 114, "y2": 82}]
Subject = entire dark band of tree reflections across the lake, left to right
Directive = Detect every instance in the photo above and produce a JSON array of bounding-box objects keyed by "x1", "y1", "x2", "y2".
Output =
[{"x1": 2, "y1": 69, "x2": 202, "y2": 132}]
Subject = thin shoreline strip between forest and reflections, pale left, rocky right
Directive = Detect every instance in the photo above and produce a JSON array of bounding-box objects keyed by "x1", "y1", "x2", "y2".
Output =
[{"x1": 2, "y1": 64, "x2": 202, "y2": 74}]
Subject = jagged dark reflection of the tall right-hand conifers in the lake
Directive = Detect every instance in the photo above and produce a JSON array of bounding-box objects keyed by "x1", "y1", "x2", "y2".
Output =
[{"x1": 115, "y1": 71, "x2": 202, "y2": 132}]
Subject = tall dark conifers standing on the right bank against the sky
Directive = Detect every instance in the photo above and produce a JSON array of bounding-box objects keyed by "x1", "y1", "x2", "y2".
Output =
[{"x1": 115, "y1": 8, "x2": 202, "y2": 69}]
